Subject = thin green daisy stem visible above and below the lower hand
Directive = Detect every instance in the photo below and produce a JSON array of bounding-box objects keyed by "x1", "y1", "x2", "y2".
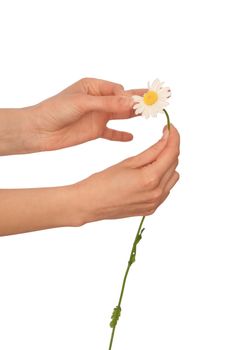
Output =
[{"x1": 109, "y1": 109, "x2": 170, "y2": 350}]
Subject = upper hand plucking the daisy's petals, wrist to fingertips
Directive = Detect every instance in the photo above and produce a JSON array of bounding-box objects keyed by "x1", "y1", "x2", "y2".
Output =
[{"x1": 33, "y1": 78, "x2": 147, "y2": 151}]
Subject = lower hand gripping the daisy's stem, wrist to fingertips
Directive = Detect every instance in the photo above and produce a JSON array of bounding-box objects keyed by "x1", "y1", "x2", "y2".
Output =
[{"x1": 68, "y1": 125, "x2": 180, "y2": 226}]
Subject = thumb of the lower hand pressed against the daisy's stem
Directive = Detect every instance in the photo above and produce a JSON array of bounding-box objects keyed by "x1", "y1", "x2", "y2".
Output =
[{"x1": 129, "y1": 128, "x2": 169, "y2": 168}]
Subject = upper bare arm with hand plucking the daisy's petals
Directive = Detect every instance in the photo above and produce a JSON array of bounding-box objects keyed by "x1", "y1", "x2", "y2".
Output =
[{"x1": 0, "y1": 78, "x2": 143, "y2": 155}]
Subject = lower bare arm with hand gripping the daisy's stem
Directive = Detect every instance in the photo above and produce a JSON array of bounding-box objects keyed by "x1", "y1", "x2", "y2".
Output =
[{"x1": 0, "y1": 126, "x2": 179, "y2": 235}]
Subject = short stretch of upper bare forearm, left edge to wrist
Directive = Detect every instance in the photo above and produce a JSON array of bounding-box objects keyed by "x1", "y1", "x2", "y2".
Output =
[{"x1": 0, "y1": 107, "x2": 40, "y2": 155}]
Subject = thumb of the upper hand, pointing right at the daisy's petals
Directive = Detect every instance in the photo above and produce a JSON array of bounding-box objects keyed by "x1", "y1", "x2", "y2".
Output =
[{"x1": 75, "y1": 94, "x2": 134, "y2": 113}]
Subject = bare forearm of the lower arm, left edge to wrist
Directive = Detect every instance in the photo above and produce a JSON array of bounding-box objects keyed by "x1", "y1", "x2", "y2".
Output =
[{"x1": 0, "y1": 186, "x2": 81, "y2": 236}]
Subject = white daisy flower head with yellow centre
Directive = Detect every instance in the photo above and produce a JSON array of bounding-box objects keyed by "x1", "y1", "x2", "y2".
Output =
[{"x1": 132, "y1": 79, "x2": 171, "y2": 118}]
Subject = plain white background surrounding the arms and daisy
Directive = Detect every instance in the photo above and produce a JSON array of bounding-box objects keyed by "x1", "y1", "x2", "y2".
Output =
[{"x1": 0, "y1": 0, "x2": 232, "y2": 350}]
